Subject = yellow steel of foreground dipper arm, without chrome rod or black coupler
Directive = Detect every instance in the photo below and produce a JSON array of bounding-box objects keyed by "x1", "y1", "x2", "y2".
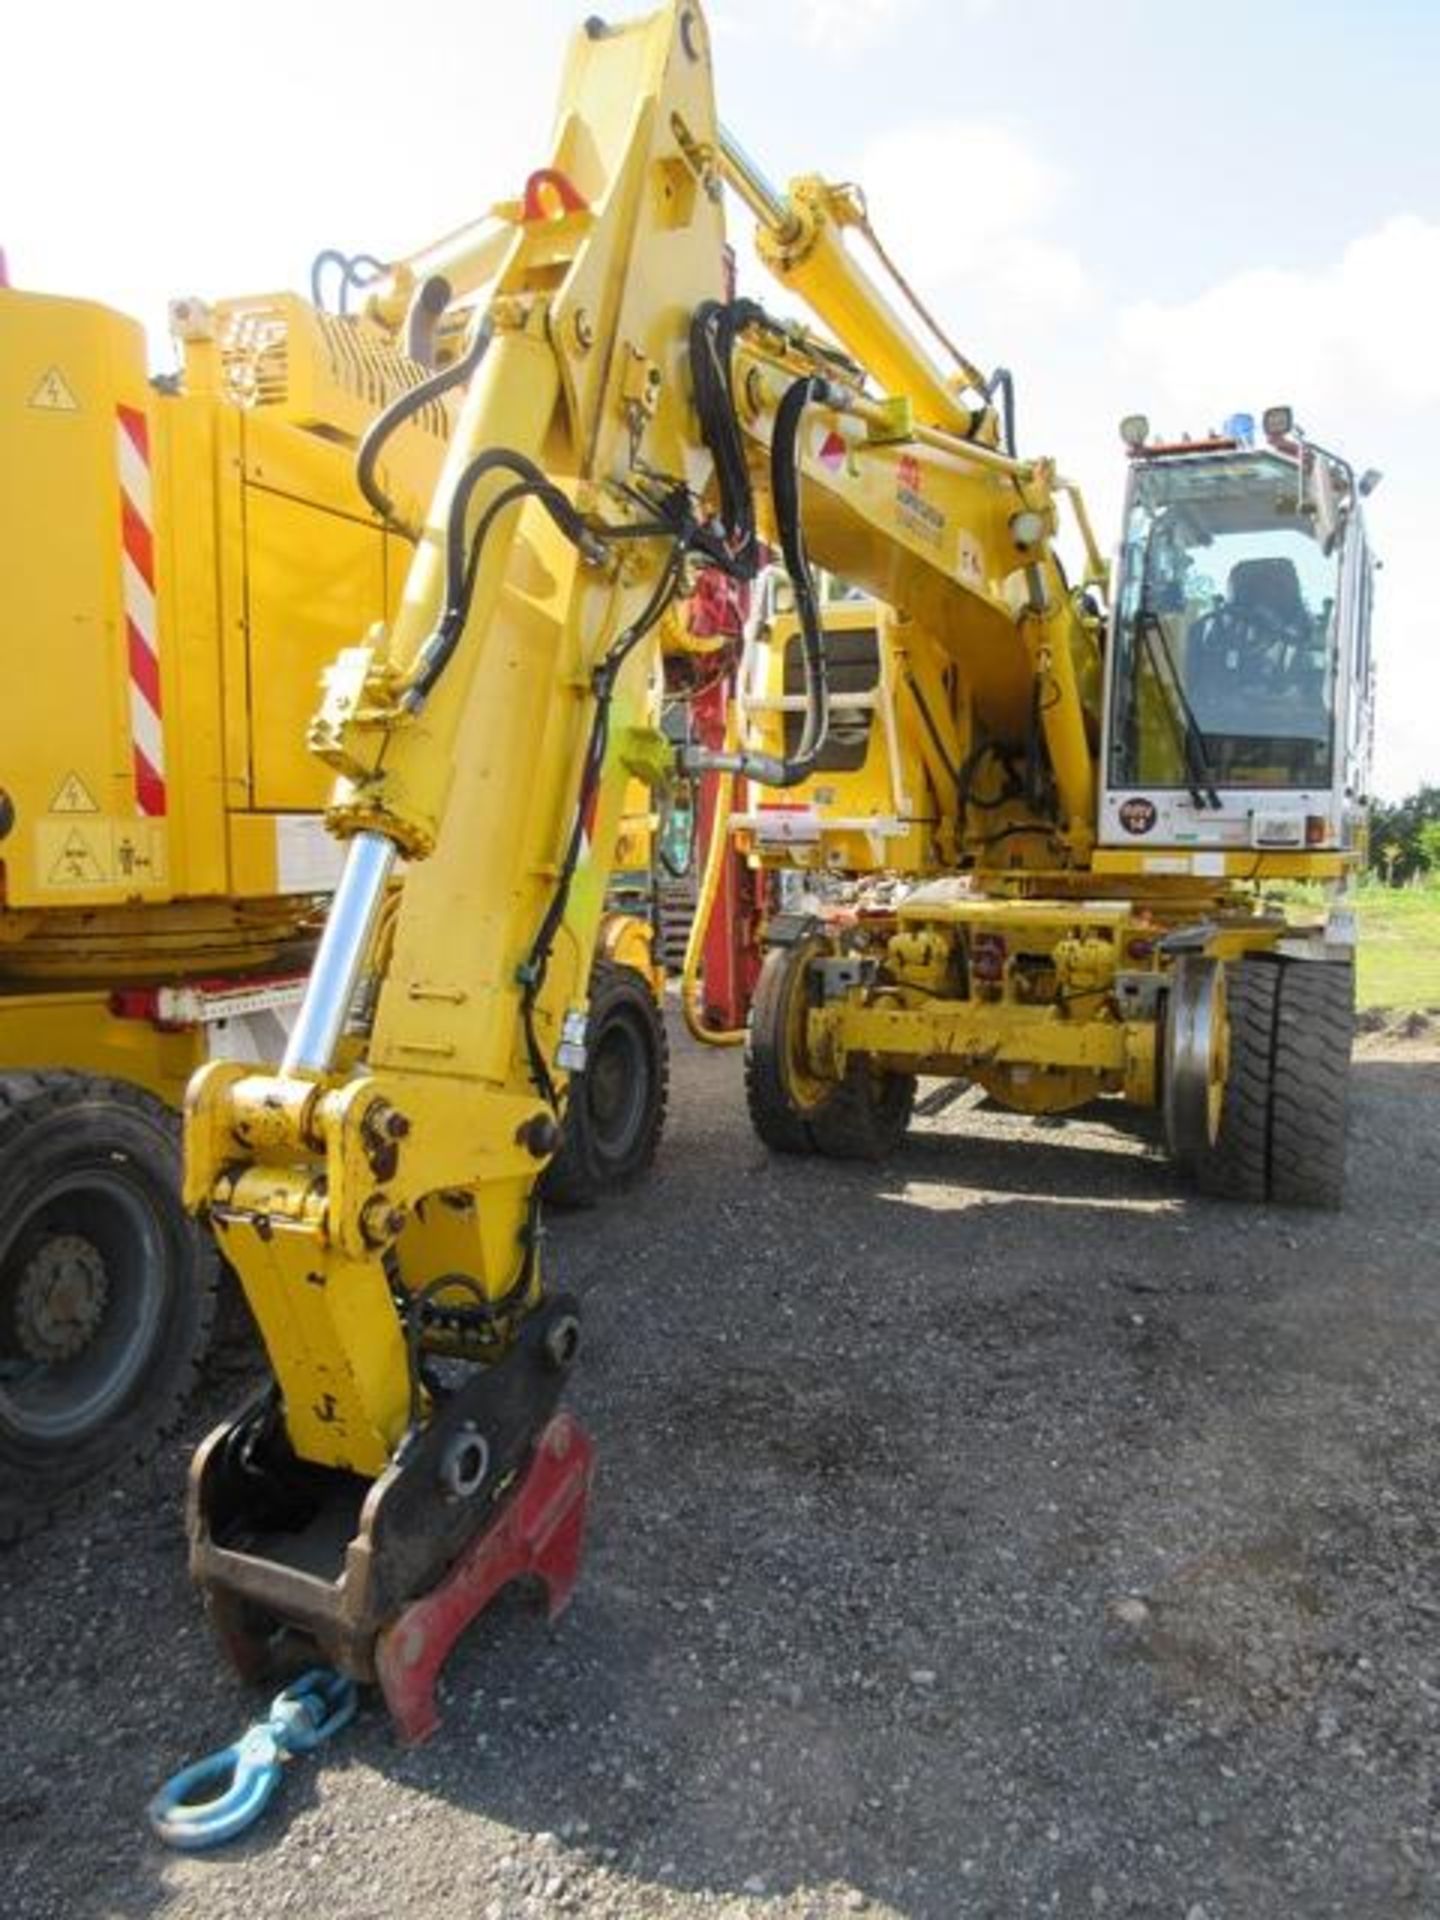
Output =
[{"x1": 186, "y1": 8, "x2": 724, "y2": 1473}]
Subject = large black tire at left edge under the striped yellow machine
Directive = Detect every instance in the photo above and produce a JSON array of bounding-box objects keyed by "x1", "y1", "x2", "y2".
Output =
[{"x1": 0, "y1": 1071, "x2": 219, "y2": 1542}]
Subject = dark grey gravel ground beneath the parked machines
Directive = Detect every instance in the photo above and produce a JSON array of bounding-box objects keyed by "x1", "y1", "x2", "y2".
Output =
[{"x1": 0, "y1": 1039, "x2": 1440, "y2": 1920}]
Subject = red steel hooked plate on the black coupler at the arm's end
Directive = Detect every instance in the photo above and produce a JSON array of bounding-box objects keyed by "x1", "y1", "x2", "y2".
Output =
[{"x1": 374, "y1": 1413, "x2": 595, "y2": 1745}]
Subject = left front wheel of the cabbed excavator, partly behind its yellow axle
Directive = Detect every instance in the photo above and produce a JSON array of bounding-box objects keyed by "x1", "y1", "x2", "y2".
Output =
[{"x1": 745, "y1": 939, "x2": 916, "y2": 1160}]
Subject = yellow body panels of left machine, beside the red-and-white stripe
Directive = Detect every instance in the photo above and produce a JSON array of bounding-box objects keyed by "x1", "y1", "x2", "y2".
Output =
[{"x1": 0, "y1": 290, "x2": 445, "y2": 983}]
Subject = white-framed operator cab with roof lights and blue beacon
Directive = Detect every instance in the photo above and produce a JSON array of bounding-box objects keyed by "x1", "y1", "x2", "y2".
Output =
[{"x1": 1100, "y1": 409, "x2": 1379, "y2": 874}]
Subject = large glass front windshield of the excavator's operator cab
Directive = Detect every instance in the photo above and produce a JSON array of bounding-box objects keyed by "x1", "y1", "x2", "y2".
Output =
[{"x1": 1110, "y1": 453, "x2": 1338, "y2": 806}]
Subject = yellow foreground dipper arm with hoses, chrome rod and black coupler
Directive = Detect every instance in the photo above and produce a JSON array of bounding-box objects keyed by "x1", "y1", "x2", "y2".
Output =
[{"x1": 186, "y1": 6, "x2": 726, "y2": 1722}]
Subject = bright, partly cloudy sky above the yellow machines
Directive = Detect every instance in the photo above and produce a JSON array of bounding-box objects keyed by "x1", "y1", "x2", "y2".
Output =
[{"x1": 0, "y1": 0, "x2": 1440, "y2": 799}]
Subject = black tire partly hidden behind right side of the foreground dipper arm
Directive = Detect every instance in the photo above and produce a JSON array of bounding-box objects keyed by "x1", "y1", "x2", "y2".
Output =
[{"x1": 541, "y1": 960, "x2": 670, "y2": 1208}]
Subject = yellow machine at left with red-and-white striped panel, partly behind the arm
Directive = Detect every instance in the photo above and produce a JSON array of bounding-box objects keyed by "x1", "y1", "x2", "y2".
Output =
[{"x1": 0, "y1": 253, "x2": 666, "y2": 1542}]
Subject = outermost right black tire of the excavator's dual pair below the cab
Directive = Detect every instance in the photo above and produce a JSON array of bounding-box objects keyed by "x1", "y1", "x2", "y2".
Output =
[{"x1": 1269, "y1": 960, "x2": 1356, "y2": 1208}]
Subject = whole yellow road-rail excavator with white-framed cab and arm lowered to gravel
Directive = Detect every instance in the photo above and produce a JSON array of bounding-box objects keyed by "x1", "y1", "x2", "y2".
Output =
[{"x1": 160, "y1": 0, "x2": 1369, "y2": 1738}]
